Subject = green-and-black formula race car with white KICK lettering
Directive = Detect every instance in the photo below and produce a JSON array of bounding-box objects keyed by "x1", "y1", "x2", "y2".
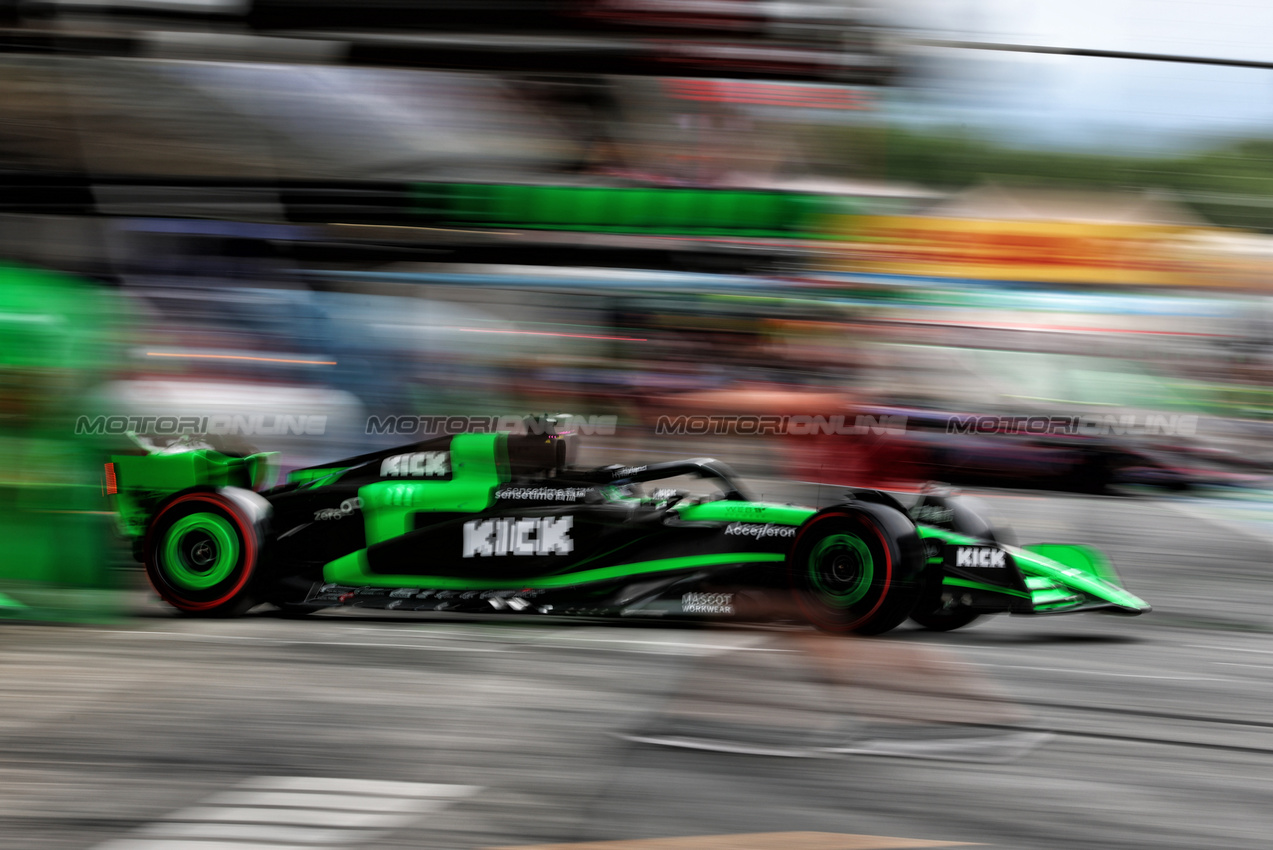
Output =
[{"x1": 106, "y1": 428, "x2": 1150, "y2": 634}]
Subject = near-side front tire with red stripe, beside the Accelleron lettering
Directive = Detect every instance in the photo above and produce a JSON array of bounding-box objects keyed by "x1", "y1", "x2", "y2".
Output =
[{"x1": 787, "y1": 508, "x2": 924, "y2": 635}]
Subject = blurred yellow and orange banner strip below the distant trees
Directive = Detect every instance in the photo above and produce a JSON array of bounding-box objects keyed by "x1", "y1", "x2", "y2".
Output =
[{"x1": 831, "y1": 215, "x2": 1237, "y2": 288}]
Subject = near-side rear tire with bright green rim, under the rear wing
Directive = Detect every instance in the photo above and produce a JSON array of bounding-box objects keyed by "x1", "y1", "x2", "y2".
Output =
[{"x1": 144, "y1": 492, "x2": 262, "y2": 617}]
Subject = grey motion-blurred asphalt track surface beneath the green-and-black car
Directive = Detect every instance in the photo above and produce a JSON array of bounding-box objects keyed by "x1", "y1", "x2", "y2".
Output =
[{"x1": 0, "y1": 494, "x2": 1273, "y2": 850}]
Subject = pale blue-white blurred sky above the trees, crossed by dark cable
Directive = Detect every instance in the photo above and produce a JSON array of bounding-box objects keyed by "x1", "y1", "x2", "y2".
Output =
[{"x1": 881, "y1": 0, "x2": 1273, "y2": 150}]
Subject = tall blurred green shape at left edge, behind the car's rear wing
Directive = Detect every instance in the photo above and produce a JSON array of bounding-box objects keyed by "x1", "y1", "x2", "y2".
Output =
[{"x1": 0, "y1": 265, "x2": 129, "y2": 622}]
